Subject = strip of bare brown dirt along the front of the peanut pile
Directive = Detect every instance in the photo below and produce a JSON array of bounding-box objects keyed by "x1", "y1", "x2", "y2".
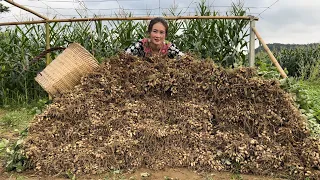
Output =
[{"x1": 0, "y1": 168, "x2": 281, "y2": 180}]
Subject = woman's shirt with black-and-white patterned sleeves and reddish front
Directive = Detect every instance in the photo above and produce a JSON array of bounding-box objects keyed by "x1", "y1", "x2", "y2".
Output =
[{"x1": 125, "y1": 38, "x2": 184, "y2": 59}]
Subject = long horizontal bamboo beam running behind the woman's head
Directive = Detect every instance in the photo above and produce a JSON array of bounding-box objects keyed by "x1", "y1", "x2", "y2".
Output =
[{"x1": 0, "y1": 16, "x2": 258, "y2": 26}]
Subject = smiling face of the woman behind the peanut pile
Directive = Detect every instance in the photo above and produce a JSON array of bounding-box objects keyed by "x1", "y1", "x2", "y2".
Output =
[{"x1": 150, "y1": 22, "x2": 166, "y2": 45}]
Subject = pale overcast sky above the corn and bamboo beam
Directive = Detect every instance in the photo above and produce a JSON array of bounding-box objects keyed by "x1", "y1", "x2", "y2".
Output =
[{"x1": 0, "y1": 0, "x2": 320, "y2": 44}]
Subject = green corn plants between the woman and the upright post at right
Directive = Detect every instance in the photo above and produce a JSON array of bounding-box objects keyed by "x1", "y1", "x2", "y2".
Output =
[{"x1": 172, "y1": 1, "x2": 249, "y2": 67}]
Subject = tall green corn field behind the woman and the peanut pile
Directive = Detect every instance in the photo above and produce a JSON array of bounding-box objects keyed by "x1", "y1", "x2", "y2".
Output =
[{"x1": 0, "y1": 1, "x2": 249, "y2": 106}]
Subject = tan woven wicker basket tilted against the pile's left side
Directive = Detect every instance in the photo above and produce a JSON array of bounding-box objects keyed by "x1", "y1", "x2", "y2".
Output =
[{"x1": 35, "y1": 43, "x2": 99, "y2": 96}]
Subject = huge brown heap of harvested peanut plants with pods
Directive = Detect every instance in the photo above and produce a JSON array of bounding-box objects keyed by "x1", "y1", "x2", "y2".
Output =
[{"x1": 24, "y1": 55, "x2": 320, "y2": 179}]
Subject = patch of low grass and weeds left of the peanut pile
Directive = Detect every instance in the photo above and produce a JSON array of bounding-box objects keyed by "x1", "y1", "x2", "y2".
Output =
[{"x1": 0, "y1": 99, "x2": 48, "y2": 172}]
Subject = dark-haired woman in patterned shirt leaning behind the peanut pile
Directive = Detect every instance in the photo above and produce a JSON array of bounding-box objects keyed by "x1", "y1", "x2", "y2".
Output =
[{"x1": 125, "y1": 17, "x2": 183, "y2": 58}]
